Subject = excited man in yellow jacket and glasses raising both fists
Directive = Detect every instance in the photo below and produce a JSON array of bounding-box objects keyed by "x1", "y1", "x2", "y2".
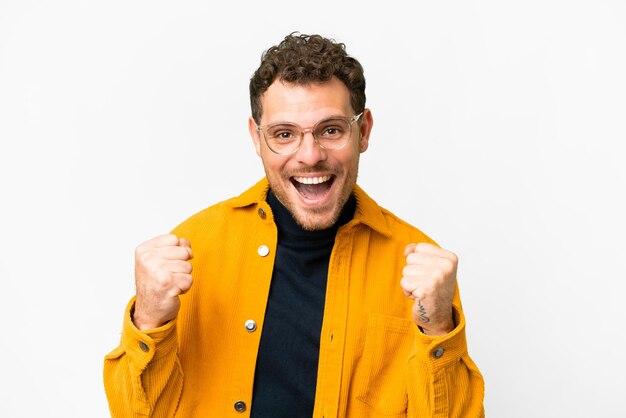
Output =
[{"x1": 104, "y1": 34, "x2": 484, "y2": 418}]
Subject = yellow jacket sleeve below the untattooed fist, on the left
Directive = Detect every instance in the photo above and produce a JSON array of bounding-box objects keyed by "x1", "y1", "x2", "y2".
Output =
[{"x1": 104, "y1": 298, "x2": 183, "y2": 417}]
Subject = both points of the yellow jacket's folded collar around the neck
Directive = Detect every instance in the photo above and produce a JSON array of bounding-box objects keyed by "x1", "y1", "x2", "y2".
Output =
[{"x1": 227, "y1": 177, "x2": 391, "y2": 237}]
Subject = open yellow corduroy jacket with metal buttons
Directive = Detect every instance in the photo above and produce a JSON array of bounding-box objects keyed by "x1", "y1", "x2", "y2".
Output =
[{"x1": 104, "y1": 179, "x2": 484, "y2": 418}]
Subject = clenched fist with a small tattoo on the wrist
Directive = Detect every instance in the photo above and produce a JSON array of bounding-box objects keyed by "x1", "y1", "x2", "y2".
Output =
[{"x1": 400, "y1": 243, "x2": 459, "y2": 336}]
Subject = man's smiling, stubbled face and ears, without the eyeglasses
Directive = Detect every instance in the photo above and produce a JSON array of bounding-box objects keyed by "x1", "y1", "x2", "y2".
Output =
[{"x1": 248, "y1": 77, "x2": 373, "y2": 230}]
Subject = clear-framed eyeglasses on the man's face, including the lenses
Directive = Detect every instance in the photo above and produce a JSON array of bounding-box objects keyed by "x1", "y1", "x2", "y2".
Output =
[{"x1": 256, "y1": 112, "x2": 363, "y2": 155}]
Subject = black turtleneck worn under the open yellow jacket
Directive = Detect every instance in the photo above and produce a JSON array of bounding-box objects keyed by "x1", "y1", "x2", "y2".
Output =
[{"x1": 251, "y1": 190, "x2": 356, "y2": 418}]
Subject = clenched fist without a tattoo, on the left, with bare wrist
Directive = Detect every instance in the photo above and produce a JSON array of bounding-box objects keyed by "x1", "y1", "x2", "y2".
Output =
[{"x1": 133, "y1": 234, "x2": 193, "y2": 330}]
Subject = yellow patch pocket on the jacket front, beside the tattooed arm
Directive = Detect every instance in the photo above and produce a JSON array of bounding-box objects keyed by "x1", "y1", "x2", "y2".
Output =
[{"x1": 355, "y1": 313, "x2": 415, "y2": 418}]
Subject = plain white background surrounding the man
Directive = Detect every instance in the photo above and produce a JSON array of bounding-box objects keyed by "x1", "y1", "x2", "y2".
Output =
[{"x1": 0, "y1": 0, "x2": 626, "y2": 418}]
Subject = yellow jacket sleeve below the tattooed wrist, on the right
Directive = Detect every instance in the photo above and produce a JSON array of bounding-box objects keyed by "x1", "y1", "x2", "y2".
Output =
[{"x1": 407, "y1": 289, "x2": 485, "y2": 418}]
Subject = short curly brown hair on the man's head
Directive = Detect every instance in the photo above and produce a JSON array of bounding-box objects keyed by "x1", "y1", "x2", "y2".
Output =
[{"x1": 250, "y1": 32, "x2": 365, "y2": 124}]
